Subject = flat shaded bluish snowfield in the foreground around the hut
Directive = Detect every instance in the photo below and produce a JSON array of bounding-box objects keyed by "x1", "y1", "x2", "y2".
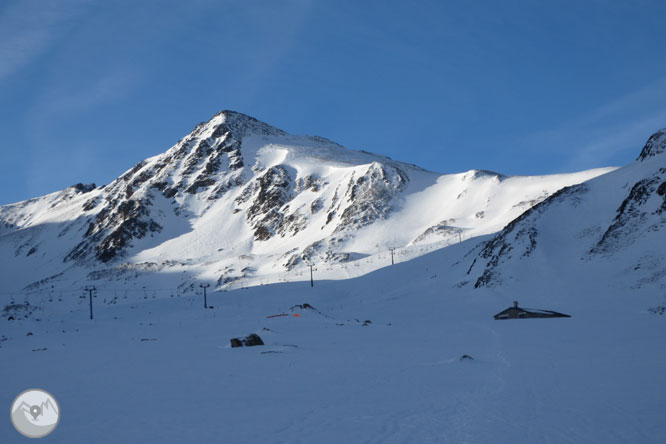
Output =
[{"x1": 0, "y1": 236, "x2": 666, "y2": 444}]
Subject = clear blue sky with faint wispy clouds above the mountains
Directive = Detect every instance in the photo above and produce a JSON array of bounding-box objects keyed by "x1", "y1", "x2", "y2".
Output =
[{"x1": 0, "y1": 0, "x2": 666, "y2": 204}]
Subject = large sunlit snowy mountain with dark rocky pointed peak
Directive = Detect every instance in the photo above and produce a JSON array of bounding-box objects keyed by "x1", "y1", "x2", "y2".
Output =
[{"x1": 0, "y1": 111, "x2": 612, "y2": 291}]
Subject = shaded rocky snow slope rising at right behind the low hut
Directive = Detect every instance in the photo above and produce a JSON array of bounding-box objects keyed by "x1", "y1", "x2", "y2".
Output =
[{"x1": 461, "y1": 130, "x2": 666, "y2": 294}]
